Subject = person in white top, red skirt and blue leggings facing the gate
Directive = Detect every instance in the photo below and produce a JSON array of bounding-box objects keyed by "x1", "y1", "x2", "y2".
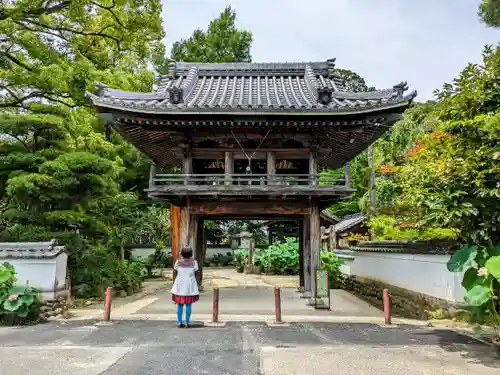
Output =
[{"x1": 171, "y1": 247, "x2": 200, "y2": 328}]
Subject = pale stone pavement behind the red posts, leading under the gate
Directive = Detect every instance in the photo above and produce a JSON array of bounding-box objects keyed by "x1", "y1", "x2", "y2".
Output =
[{"x1": 69, "y1": 268, "x2": 383, "y2": 322}]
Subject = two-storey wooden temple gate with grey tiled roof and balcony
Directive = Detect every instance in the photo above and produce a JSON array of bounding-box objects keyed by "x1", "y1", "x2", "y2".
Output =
[{"x1": 87, "y1": 59, "x2": 416, "y2": 300}]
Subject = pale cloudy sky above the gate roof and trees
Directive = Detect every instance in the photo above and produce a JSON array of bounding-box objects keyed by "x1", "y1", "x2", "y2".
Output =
[{"x1": 162, "y1": 0, "x2": 500, "y2": 101}]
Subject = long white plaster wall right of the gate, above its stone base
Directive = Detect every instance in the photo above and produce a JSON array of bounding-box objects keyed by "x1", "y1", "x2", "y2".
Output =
[{"x1": 341, "y1": 251, "x2": 465, "y2": 302}]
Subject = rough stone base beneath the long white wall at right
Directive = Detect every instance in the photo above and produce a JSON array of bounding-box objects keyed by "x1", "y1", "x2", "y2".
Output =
[{"x1": 343, "y1": 276, "x2": 460, "y2": 320}]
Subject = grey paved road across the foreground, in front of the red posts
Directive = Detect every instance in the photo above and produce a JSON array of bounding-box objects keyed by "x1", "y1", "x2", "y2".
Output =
[{"x1": 0, "y1": 321, "x2": 500, "y2": 375}]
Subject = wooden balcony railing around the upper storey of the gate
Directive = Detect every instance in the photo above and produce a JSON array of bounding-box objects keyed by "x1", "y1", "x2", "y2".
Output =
[{"x1": 150, "y1": 173, "x2": 345, "y2": 188}]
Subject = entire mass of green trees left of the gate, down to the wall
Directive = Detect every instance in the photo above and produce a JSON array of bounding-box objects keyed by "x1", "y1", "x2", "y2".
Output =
[{"x1": 0, "y1": 0, "x2": 168, "y2": 293}]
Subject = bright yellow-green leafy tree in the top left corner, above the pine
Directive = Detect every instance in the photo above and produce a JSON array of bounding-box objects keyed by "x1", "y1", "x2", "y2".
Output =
[{"x1": 0, "y1": 0, "x2": 163, "y2": 108}]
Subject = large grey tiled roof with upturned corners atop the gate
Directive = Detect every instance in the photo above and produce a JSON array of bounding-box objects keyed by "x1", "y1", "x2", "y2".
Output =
[{"x1": 87, "y1": 59, "x2": 416, "y2": 114}]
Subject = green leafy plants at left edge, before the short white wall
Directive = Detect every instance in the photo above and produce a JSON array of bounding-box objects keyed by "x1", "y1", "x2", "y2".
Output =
[{"x1": 0, "y1": 263, "x2": 41, "y2": 324}]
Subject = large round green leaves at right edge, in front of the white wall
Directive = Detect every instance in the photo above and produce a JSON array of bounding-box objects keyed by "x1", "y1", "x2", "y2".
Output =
[{"x1": 447, "y1": 246, "x2": 500, "y2": 357}]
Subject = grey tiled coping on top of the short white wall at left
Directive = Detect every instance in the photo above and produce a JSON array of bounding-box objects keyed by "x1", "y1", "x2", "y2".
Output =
[{"x1": 0, "y1": 240, "x2": 64, "y2": 259}]
